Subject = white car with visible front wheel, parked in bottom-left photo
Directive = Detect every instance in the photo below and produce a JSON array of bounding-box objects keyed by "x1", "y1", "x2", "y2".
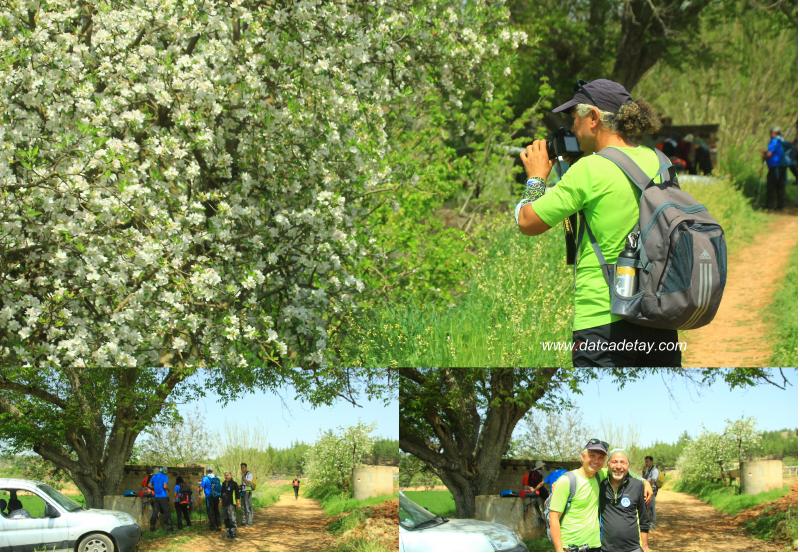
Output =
[{"x1": 0, "y1": 478, "x2": 142, "y2": 551}]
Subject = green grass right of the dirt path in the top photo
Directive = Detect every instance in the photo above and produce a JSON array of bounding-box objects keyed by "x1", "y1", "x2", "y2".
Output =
[{"x1": 767, "y1": 248, "x2": 797, "y2": 367}]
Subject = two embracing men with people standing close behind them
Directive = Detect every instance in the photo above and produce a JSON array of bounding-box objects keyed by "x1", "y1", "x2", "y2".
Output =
[{"x1": 523, "y1": 439, "x2": 659, "y2": 551}]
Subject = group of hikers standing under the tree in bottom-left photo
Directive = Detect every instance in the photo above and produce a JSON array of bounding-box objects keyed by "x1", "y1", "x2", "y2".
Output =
[{"x1": 141, "y1": 463, "x2": 256, "y2": 539}]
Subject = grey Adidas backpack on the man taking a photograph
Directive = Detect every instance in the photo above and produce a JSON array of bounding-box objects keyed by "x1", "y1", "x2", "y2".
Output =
[{"x1": 578, "y1": 148, "x2": 727, "y2": 329}]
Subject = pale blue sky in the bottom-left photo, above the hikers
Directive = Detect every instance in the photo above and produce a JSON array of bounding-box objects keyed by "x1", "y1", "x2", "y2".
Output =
[{"x1": 179, "y1": 388, "x2": 399, "y2": 448}]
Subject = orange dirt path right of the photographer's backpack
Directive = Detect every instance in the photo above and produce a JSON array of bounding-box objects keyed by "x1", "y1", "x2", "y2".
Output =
[{"x1": 683, "y1": 213, "x2": 797, "y2": 367}]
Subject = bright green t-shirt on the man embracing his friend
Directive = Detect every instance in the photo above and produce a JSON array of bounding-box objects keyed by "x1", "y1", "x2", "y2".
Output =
[{"x1": 550, "y1": 468, "x2": 608, "y2": 547}]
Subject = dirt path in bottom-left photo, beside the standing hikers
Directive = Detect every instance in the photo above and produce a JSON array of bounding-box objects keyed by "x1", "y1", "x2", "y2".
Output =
[{"x1": 140, "y1": 492, "x2": 334, "y2": 551}]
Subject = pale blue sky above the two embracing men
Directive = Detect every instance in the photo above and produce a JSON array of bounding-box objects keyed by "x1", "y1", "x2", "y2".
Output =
[{"x1": 518, "y1": 369, "x2": 798, "y2": 446}]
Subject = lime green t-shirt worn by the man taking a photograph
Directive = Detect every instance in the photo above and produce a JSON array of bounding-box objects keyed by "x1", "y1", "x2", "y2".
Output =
[{"x1": 532, "y1": 146, "x2": 659, "y2": 330}]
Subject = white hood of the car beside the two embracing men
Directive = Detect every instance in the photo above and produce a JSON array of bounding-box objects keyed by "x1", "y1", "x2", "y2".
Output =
[{"x1": 410, "y1": 518, "x2": 520, "y2": 551}]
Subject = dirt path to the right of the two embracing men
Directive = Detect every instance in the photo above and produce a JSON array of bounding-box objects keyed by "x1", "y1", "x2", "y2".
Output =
[{"x1": 650, "y1": 490, "x2": 786, "y2": 551}]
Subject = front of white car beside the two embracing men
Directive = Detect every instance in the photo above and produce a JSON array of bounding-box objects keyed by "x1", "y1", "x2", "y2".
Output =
[{"x1": 400, "y1": 492, "x2": 528, "y2": 551}]
